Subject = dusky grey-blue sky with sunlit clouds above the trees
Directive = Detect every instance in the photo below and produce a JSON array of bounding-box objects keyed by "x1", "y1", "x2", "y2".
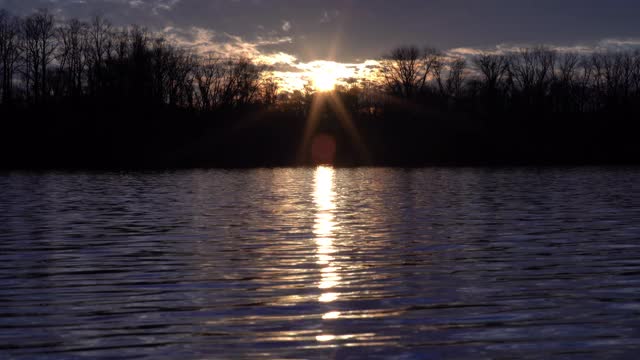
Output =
[{"x1": 0, "y1": 0, "x2": 640, "y2": 90}]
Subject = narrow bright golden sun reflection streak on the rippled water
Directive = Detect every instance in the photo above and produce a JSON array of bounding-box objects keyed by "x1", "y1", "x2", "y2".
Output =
[{"x1": 313, "y1": 166, "x2": 341, "y2": 342}]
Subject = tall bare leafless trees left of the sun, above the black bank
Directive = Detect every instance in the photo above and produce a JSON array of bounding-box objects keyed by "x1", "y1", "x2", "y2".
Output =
[{"x1": 0, "y1": 10, "x2": 277, "y2": 110}]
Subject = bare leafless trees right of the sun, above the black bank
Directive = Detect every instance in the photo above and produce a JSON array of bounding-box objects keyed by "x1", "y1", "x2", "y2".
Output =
[{"x1": 381, "y1": 46, "x2": 640, "y2": 113}]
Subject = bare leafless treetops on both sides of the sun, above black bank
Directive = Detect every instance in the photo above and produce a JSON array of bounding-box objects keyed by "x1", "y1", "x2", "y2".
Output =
[{"x1": 0, "y1": 10, "x2": 640, "y2": 113}]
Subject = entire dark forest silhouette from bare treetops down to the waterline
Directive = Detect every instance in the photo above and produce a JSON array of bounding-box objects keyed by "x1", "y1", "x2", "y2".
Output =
[{"x1": 0, "y1": 10, "x2": 640, "y2": 169}]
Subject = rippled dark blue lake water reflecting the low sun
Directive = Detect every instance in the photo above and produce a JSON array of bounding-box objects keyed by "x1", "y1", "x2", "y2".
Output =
[{"x1": 0, "y1": 168, "x2": 640, "y2": 359}]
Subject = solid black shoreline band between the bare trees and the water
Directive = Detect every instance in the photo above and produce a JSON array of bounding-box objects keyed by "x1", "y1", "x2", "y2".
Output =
[{"x1": 0, "y1": 109, "x2": 640, "y2": 171}]
